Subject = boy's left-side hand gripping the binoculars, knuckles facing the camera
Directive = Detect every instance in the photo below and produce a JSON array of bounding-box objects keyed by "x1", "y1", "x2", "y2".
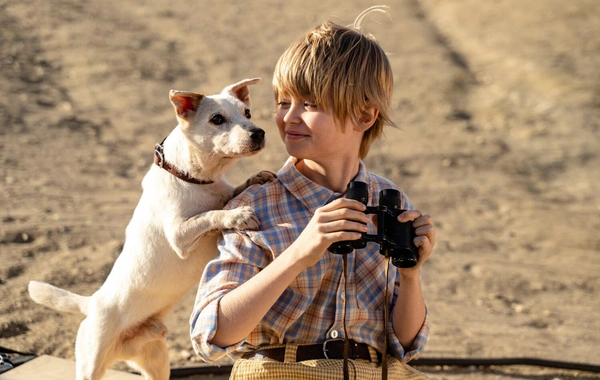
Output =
[{"x1": 290, "y1": 198, "x2": 369, "y2": 268}]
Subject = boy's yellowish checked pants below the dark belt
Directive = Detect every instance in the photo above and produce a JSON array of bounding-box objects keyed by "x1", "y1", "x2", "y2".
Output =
[{"x1": 230, "y1": 356, "x2": 427, "y2": 380}]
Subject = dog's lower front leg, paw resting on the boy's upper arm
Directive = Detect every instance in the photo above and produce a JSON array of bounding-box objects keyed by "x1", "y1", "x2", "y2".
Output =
[{"x1": 165, "y1": 207, "x2": 258, "y2": 260}]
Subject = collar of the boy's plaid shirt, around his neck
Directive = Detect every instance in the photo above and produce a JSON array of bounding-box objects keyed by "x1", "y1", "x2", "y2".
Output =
[{"x1": 277, "y1": 157, "x2": 371, "y2": 213}]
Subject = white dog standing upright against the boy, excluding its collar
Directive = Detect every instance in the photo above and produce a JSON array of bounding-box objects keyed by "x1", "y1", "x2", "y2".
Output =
[{"x1": 29, "y1": 78, "x2": 274, "y2": 380}]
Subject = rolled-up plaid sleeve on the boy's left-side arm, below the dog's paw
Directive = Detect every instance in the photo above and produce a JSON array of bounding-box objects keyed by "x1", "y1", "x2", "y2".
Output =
[{"x1": 190, "y1": 230, "x2": 264, "y2": 364}]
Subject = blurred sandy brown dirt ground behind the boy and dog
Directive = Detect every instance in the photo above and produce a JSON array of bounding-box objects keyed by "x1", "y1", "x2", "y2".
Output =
[{"x1": 0, "y1": 0, "x2": 600, "y2": 379}]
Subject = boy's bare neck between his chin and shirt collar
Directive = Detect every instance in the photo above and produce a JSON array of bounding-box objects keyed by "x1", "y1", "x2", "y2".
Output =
[{"x1": 296, "y1": 159, "x2": 359, "y2": 193}]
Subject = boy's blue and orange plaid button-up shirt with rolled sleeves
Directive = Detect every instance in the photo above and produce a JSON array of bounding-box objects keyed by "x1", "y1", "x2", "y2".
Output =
[{"x1": 190, "y1": 158, "x2": 429, "y2": 363}]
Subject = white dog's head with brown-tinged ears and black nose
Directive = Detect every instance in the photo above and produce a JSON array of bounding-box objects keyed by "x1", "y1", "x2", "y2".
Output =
[{"x1": 169, "y1": 78, "x2": 265, "y2": 158}]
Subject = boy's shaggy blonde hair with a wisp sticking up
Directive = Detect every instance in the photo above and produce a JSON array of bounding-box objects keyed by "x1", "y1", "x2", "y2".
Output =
[{"x1": 273, "y1": 9, "x2": 395, "y2": 159}]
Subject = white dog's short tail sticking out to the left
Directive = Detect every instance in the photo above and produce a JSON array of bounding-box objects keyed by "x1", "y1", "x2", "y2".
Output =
[{"x1": 28, "y1": 281, "x2": 90, "y2": 315}]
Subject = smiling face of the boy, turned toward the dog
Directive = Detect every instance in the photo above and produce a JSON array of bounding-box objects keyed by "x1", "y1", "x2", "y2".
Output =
[{"x1": 275, "y1": 97, "x2": 363, "y2": 165}]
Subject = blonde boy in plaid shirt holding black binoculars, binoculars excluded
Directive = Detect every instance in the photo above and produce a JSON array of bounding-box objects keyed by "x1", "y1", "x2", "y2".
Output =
[{"x1": 191, "y1": 10, "x2": 435, "y2": 379}]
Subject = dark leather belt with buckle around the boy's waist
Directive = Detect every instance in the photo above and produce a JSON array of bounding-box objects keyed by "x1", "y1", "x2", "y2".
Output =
[{"x1": 243, "y1": 339, "x2": 381, "y2": 363}]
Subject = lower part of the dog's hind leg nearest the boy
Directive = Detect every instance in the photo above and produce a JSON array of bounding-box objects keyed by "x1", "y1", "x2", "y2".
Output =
[{"x1": 127, "y1": 338, "x2": 170, "y2": 380}]
